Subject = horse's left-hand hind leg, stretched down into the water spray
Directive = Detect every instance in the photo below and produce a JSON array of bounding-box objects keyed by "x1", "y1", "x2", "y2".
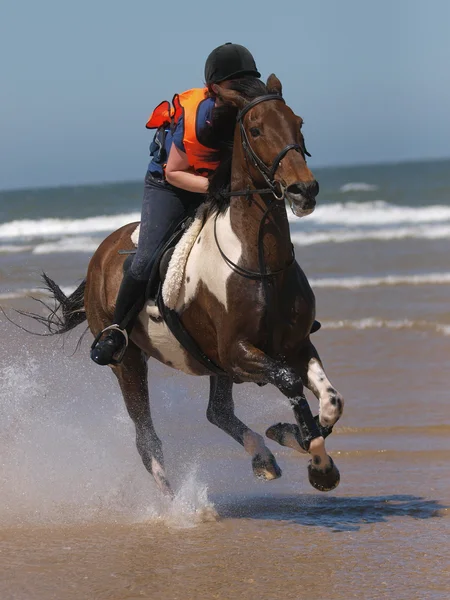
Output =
[{"x1": 113, "y1": 342, "x2": 173, "y2": 497}]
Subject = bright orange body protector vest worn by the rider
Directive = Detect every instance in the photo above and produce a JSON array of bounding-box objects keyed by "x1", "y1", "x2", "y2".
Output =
[{"x1": 146, "y1": 88, "x2": 219, "y2": 173}]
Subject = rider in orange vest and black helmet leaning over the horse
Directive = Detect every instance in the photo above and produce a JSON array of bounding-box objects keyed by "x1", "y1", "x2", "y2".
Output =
[{"x1": 91, "y1": 42, "x2": 261, "y2": 365}]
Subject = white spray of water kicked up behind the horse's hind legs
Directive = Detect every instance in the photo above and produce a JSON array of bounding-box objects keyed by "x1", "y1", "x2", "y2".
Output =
[{"x1": 0, "y1": 338, "x2": 217, "y2": 528}]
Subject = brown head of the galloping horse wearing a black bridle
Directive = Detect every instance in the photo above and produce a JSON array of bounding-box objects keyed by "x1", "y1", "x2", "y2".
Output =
[{"x1": 215, "y1": 75, "x2": 319, "y2": 217}]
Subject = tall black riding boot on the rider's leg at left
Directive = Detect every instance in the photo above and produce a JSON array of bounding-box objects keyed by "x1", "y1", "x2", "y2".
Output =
[{"x1": 91, "y1": 272, "x2": 147, "y2": 365}]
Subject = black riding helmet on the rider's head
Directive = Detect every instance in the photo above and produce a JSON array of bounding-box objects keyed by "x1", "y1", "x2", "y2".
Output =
[{"x1": 205, "y1": 42, "x2": 261, "y2": 84}]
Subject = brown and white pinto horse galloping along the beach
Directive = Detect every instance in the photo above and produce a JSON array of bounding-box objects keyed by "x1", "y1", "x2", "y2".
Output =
[{"x1": 38, "y1": 75, "x2": 343, "y2": 495}]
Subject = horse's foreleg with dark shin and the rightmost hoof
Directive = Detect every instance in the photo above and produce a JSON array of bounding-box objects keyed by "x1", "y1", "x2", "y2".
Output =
[{"x1": 233, "y1": 342, "x2": 340, "y2": 491}]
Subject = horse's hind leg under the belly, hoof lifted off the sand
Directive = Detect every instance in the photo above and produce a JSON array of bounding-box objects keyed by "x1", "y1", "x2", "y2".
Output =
[{"x1": 206, "y1": 376, "x2": 281, "y2": 480}]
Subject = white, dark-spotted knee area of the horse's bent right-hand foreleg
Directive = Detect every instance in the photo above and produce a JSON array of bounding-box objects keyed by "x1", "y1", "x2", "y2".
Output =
[{"x1": 306, "y1": 358, "x2": 344, "y2": 426}]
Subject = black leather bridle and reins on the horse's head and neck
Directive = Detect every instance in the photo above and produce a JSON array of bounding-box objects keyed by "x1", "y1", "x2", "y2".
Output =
[{"x1": 214, "y1": 94, "x2": 310, "y2": 288}]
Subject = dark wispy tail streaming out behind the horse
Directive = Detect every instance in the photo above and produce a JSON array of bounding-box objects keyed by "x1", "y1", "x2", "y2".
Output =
[{"x1": 6, "y1": 273, "x2": 86, "y2": 341}]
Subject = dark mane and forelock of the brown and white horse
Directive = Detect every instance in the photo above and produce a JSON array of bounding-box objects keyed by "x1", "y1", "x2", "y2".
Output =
[{"x1": 208, "y1": 77, "x2": 269, "y2": 212}]
